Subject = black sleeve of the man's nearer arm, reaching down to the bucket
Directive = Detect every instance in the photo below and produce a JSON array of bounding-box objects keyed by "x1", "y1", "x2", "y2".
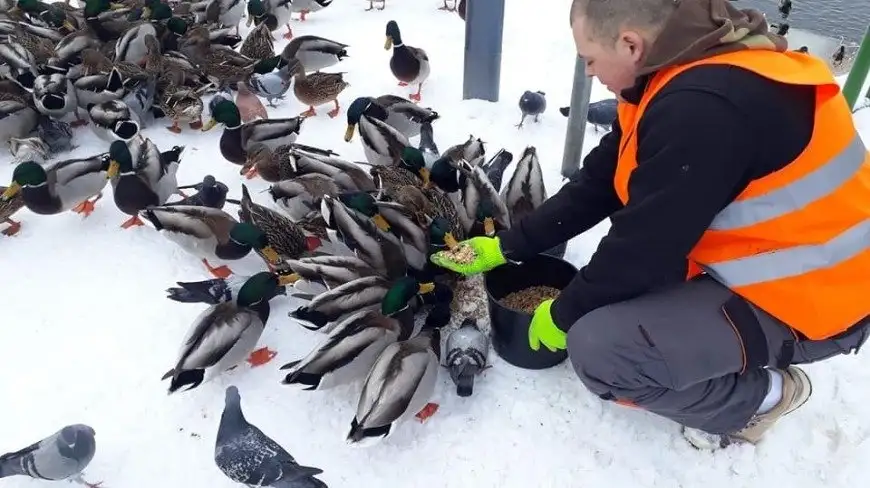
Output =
[{"x1": 551, "y1": 87, "x2": 763, "y2": 331}]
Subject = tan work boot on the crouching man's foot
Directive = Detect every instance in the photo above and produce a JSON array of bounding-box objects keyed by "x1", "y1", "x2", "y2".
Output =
[{"x1": 683, "y1": 366, "x2": 813, "y2": 450}]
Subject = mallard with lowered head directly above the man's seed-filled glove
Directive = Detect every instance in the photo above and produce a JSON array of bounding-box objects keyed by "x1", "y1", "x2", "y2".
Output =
[{"x1": 459, "y1": 160, "x2": 511, "y2": 237}]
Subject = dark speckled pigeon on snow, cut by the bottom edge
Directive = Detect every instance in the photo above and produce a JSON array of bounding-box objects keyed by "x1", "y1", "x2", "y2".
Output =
[{"x1": 214, "y1": 386, "x2": 328, "y2": 488}]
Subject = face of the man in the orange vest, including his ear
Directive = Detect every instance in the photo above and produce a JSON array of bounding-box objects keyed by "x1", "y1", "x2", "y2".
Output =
[{"x1": 573, "y1": 16, "x2": 643, "y2": 96}]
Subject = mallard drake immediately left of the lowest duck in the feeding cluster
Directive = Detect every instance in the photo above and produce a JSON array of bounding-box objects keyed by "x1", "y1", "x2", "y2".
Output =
[{"x1": 281, "y1": 302, "x2": 417, "y2": 391}]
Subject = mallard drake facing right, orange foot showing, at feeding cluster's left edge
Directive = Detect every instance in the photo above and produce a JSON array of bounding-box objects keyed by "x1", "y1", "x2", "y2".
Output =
[{"x1": 141, "y1": 205, "x2": 280, "y2": 278}]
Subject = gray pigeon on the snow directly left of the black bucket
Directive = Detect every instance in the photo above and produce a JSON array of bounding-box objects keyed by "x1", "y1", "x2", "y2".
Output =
[{"x1": 444, "y1": 318, "x2": 489, "y2": 397}]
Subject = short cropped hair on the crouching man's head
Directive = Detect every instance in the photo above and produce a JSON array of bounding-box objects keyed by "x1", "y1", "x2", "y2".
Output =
[{"x1": 571, "y1": 0, "x2": 684, "y2": 42}]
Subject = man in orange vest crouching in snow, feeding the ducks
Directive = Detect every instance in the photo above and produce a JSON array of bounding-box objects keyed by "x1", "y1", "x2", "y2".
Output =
[{"x1": 433, "y1": 0, "x2": 870, "y2": 449}]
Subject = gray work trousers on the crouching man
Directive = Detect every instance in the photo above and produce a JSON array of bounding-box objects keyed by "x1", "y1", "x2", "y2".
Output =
[{"x1": 568, "y1": 275, "x2": 870, "y2": 434}]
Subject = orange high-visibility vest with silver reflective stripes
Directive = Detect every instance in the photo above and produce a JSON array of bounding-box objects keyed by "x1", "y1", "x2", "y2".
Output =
[{"x1": 613, "y1": 51, "x2": 870, "y2": 340}]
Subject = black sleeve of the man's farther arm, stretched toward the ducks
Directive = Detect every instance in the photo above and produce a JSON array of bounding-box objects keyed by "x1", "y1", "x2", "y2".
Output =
[{"x1": 498, "y1": 122, "x2": 622, "y2": 260}]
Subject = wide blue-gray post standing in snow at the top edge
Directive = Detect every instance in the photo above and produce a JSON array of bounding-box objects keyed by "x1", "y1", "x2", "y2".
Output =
[{"x1": 462, "y1": 0, "x2": 504, "y2": 102}]
